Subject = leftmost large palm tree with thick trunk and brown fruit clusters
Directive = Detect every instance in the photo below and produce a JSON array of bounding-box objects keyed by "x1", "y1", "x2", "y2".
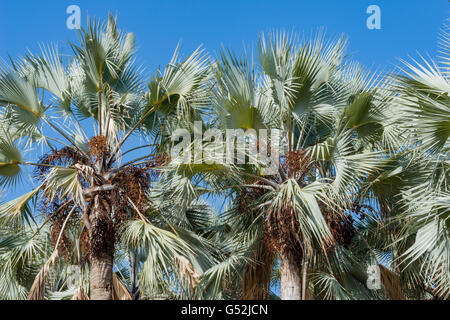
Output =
[{"x1": 0, "y1": 16, "x2": 213, "y2": 299}]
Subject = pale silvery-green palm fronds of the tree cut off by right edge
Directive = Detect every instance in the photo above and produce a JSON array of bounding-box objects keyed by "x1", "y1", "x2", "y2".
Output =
[{"x1": 386, "y1": 21, "x2": 450, "y2": 299}]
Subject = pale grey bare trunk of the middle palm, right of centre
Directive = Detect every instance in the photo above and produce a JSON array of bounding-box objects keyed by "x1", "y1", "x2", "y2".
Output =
[{"x1": 280, "y1": 254, "x2": 301, "y2": 300}]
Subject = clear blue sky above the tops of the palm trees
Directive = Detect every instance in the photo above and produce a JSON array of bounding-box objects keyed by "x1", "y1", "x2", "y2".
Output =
[{"x1": 0, "y1": 0, "x2": 450, "y2": 71}]
